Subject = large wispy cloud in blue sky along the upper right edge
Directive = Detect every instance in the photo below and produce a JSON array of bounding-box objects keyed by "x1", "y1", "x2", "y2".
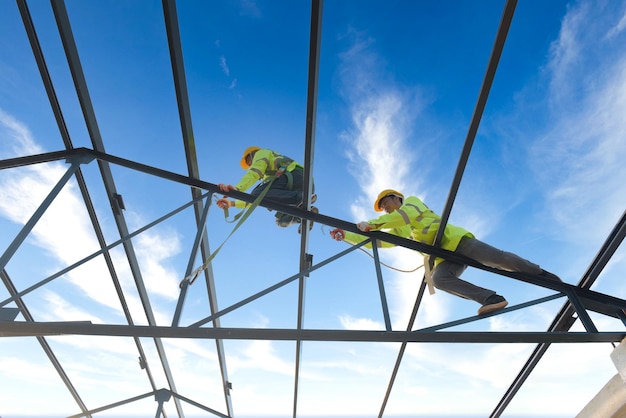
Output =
[{"x1": 533, "y1": 2, "x2": 626, "y2": 245}]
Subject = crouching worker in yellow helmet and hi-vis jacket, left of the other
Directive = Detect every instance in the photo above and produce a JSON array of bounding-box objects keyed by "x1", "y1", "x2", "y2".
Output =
[{"x1": 217, "y1": 146, "x2": 319, "y2": 232}]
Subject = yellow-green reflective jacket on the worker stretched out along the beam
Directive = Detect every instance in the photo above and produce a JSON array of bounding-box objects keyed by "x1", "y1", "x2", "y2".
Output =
[{"x1": 344, "y1": 196, "x2": 474, "y2": 266}]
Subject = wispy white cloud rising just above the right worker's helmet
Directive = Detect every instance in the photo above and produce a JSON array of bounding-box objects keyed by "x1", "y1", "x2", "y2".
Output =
[{"x1": 339, "y1": 31, "x2": 419, "y2": 209}]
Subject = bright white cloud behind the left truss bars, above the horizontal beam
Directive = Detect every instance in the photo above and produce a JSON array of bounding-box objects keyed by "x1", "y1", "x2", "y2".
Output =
[{"x1": 0, "y1": 112, "x2": 185, "y2": 317}]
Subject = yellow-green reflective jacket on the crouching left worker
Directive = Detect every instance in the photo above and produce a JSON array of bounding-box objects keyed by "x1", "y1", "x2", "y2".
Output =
[{"x1": 235, "y1": 148, "x2": 304, "y2": 208}]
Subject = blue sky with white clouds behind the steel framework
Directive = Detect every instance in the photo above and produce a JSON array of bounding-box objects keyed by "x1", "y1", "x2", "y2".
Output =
[{"x1": 0, "y1": 0, "x2": 626, "y2": 416}]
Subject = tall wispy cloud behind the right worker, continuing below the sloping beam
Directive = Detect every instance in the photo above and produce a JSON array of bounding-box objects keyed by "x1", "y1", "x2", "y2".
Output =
[{"x1": 338, "y1": 29, "x2": 443, "y2": 327}]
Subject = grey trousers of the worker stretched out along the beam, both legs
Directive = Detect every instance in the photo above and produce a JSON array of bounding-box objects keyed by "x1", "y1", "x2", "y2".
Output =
[{"x1": 431, "y1": 237, "x2": 541, "y2": 305}]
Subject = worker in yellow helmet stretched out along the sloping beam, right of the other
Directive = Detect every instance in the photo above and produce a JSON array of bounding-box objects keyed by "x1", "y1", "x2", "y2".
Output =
[{"x1": 330, "y1": 189, "x2": 561, "y2": 315}]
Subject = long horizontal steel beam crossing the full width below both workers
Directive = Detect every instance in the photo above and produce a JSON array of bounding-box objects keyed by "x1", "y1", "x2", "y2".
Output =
[{"x1": 0, "y1": 322, "x2": 626, "y2": 343}]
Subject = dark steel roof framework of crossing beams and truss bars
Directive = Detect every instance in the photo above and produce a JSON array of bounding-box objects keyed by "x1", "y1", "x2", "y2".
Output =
[{"x1": 0, "y1": 0, "x2": 626, "y2": 417}]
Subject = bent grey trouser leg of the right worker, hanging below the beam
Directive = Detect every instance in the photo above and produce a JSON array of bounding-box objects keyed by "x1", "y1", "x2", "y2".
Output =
[{"x1": 432, "y1": 260, "x2": 495, "y2": 305}]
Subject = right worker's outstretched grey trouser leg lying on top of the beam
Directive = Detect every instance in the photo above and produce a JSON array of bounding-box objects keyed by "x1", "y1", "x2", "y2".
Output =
[{"x1": 456, "y1": 237, "x2": 542, "y2": 274}]
